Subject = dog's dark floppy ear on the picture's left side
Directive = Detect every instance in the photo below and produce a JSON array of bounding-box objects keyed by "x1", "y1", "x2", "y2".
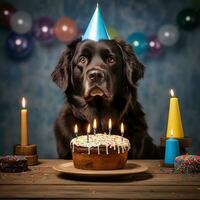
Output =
[{"x1": 51, "y1": 39, "x2": 80, "y2": 91}]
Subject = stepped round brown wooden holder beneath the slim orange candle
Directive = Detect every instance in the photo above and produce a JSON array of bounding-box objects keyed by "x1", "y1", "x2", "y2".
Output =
[{"x1": 13, "y1": 144, "x2": 38, "y2": 166}]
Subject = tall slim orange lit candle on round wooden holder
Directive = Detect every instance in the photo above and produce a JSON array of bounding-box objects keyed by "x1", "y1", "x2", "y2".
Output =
[{"x1": 21, "y1": 97, "x2": 28, "y2": 146}]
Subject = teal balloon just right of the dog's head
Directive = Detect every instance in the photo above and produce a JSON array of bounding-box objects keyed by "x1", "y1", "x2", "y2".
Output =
[{"x1": 128, "y1": 32, "x2": 148, "y2": 54}]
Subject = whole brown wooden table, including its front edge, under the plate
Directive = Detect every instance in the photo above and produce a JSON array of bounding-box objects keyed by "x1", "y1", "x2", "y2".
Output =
[{"x1": 0, "y1": 160, "x2": 200, "y2": 200}]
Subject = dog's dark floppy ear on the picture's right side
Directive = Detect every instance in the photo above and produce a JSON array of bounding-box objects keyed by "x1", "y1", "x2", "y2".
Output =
[{"x1": 115, "y1": 38, "x2": 144, "y2": 86}]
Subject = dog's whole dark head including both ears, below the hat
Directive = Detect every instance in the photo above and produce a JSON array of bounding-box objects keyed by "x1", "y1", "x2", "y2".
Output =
[{"x1": 52, "y1": 40, "x2": 144, "y2": 102}]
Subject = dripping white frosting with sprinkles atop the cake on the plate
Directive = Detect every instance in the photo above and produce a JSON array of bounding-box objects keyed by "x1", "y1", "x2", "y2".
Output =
[{"x1": 70, "y1": 133, "x2": 130, "y2": 154}]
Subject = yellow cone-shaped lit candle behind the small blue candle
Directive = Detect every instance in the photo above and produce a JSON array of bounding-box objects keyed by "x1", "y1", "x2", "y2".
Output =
[{"x1": 166, "y1": 89, "x2": 184, "y2": 138}]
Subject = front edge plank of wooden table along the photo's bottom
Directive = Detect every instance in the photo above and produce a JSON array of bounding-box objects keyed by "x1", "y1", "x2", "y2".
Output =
[{"x1": 0, "y1": 185, "x2": 200, "y2": 200}]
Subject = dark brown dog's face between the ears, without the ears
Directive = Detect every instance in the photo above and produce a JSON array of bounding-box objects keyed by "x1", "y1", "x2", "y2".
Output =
[{"x1": 72, "y1": 40, "x2": 123, "y2": 101}]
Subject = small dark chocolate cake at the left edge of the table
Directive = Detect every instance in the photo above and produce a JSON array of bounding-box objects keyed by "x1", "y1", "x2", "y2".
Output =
[{"x1": 0, "y1": 155, "x2": 28, "y2": 172}]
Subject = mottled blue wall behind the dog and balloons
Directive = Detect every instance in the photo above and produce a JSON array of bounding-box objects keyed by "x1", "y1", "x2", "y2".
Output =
[{"x1": 0, "y1": 0, "x2": 200, "y2": 158}]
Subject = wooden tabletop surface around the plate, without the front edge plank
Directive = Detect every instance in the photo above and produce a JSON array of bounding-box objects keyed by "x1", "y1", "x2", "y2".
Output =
[{"x1": 0, "y1": 160, "x2": 200, "y2": 186}]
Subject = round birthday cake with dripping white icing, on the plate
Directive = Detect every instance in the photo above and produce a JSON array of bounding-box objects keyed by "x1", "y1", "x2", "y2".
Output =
[{"x1": 70, "y1": 133, "x2": 130, "y2": 170}]
